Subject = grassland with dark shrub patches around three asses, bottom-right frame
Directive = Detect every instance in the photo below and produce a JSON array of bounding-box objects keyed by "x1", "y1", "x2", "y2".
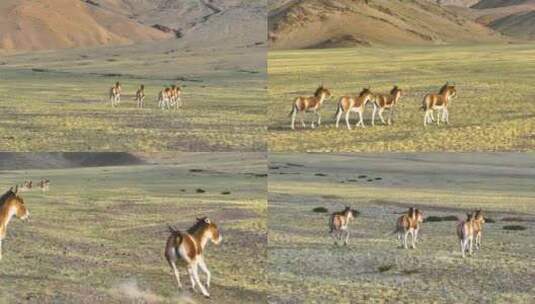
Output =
[{"x1": 268, "y1": 153, "x2": 535, "y2": 303}]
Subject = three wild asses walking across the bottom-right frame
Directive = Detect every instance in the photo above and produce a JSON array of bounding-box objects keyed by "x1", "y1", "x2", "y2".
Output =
[{"x1": 329, "y1": 207, "x2": 485, "y2": 258}]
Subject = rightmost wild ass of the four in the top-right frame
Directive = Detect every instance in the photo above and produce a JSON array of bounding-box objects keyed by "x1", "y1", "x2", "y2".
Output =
[{"x1": 421, "y1": 83, "x2": 457, "y2": 126}]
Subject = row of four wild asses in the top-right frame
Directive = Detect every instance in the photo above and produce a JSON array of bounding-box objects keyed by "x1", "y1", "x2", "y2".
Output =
[{"x1": 290, "y1": 82, "x2": 457, "y2": 130}]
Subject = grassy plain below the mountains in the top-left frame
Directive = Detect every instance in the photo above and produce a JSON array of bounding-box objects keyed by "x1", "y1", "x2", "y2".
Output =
[{"x1": 0, "y1": 41, "x2": 267, "y2": 151}]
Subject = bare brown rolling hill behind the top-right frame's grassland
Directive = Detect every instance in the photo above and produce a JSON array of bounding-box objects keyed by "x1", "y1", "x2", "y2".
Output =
[{"x1": 269, "y1": 0, "x2": 505, "y2": 49}]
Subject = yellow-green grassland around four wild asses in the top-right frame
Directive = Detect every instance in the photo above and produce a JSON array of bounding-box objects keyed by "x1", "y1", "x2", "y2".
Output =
[{"x1": 268, "y1": 45, "x2": 535, "y2": 152}]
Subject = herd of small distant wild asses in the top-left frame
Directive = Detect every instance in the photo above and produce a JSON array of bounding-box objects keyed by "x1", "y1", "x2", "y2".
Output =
[{"x1": 109, "y1": 82, "x2": 183, "y2": 110}]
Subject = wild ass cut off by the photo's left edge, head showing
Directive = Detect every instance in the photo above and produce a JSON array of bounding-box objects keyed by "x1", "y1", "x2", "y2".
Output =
[{"x1": 0, "y1": 186, "x2": 30, "y2": 260}]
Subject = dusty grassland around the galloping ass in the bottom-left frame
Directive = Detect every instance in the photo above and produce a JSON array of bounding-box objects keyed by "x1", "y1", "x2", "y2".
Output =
[{"x1": 0, "y1": 154, "x2": 267, "y2": 303}]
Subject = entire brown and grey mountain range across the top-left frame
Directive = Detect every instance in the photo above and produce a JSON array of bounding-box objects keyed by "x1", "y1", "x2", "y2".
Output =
[{"x1": 0, "y1": 0, "x2": 266, "y2": 51}]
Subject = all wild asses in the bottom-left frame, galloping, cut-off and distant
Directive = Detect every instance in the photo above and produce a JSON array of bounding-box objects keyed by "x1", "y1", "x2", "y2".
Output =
[{"x1": 0, "y1": 185, "x2": 222, "y2": 298}]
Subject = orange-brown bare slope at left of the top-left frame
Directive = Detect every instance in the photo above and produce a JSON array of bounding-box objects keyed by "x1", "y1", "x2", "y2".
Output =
[{"x1": 0, "y1": 0, "x2": 169, "y2": 50}]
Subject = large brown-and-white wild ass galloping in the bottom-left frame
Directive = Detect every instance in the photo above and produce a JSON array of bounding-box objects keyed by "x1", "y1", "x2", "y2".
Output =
[{"x1": 165, "y1": 217, "x2": 222, "y2": 297}]
